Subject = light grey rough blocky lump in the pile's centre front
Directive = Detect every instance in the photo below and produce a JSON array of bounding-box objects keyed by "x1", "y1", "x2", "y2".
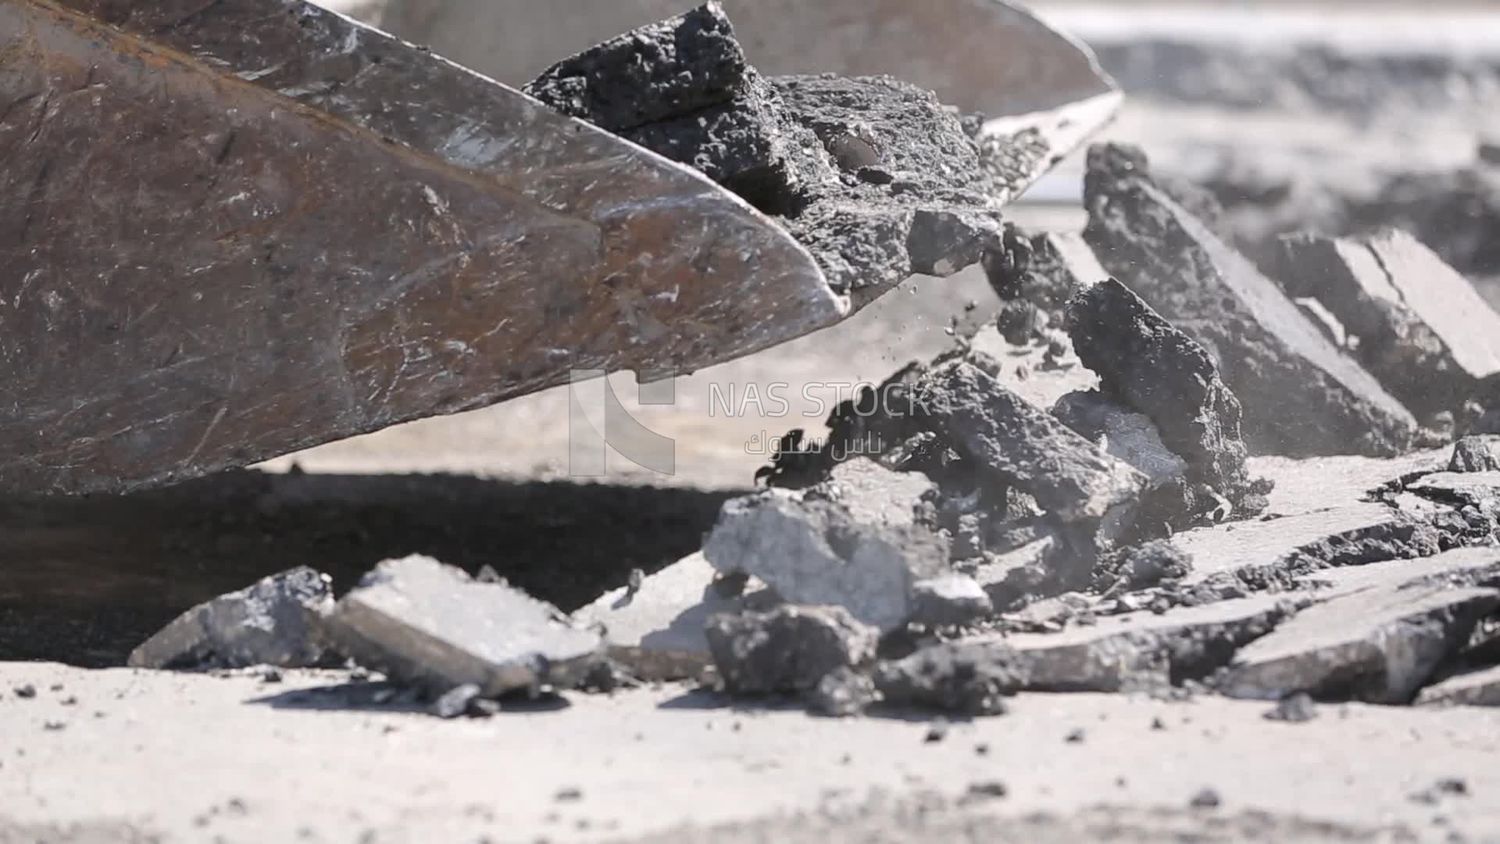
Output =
[{"x1": 704, "y1": 459, "x2": 948, "y2": 631}]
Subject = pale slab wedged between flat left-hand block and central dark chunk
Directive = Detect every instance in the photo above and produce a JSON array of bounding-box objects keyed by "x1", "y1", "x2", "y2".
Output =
[{"x1": 573, "y1": 553, "x2": 777, "y2": 681}]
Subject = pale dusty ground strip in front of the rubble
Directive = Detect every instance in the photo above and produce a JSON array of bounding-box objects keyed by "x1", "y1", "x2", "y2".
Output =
[{"x1": 0, "y1": 664, "x2": 1500, "y2": 841}]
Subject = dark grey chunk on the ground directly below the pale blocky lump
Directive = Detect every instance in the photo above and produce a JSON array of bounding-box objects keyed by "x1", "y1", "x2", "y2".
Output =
[{"x1": 707, "y1": 604, "x2": 881, "y2": 694}]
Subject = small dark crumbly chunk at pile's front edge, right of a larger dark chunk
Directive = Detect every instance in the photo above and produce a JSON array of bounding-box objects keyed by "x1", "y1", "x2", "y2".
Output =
[{"x1": 875, "y1": 642, "x2": 1025, "y2": 715}]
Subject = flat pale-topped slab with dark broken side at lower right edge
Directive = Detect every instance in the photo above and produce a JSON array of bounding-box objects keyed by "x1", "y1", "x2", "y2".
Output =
[{"x1": 1217, "y1": 582, "x2": 1500, "y2": 703}]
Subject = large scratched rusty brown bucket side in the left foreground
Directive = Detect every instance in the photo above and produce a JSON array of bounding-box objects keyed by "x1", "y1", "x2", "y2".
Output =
[{"x1": 0, "y1": 0, "x2": 848, "y2": 493}]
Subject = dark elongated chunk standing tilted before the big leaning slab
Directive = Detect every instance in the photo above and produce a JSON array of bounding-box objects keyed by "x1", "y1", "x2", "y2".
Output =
[{"x1": 1068, "y1": 279, "x2": 1265, "y2": 514}]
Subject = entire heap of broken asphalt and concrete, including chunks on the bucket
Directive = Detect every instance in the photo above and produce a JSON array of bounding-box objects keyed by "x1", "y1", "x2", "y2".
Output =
[{"x1": 117, "y1": 4, "x2": 1500, "y2": 720}]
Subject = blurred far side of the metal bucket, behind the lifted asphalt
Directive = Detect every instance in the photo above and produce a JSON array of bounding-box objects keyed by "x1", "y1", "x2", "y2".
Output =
[{"x1": 381, "y1": 0, "x2": 1121, "y2": 202}]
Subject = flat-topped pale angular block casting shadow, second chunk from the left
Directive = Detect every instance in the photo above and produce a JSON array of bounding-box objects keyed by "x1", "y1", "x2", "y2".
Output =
[{"x1": 323, "y1": 556, "x2": 605, "y2": 697}]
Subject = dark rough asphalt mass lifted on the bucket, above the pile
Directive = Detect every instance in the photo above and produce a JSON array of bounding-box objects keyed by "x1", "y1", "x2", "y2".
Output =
[{"x1": 527, "y1": 3, "x2": 1002, "y2": 307}]
